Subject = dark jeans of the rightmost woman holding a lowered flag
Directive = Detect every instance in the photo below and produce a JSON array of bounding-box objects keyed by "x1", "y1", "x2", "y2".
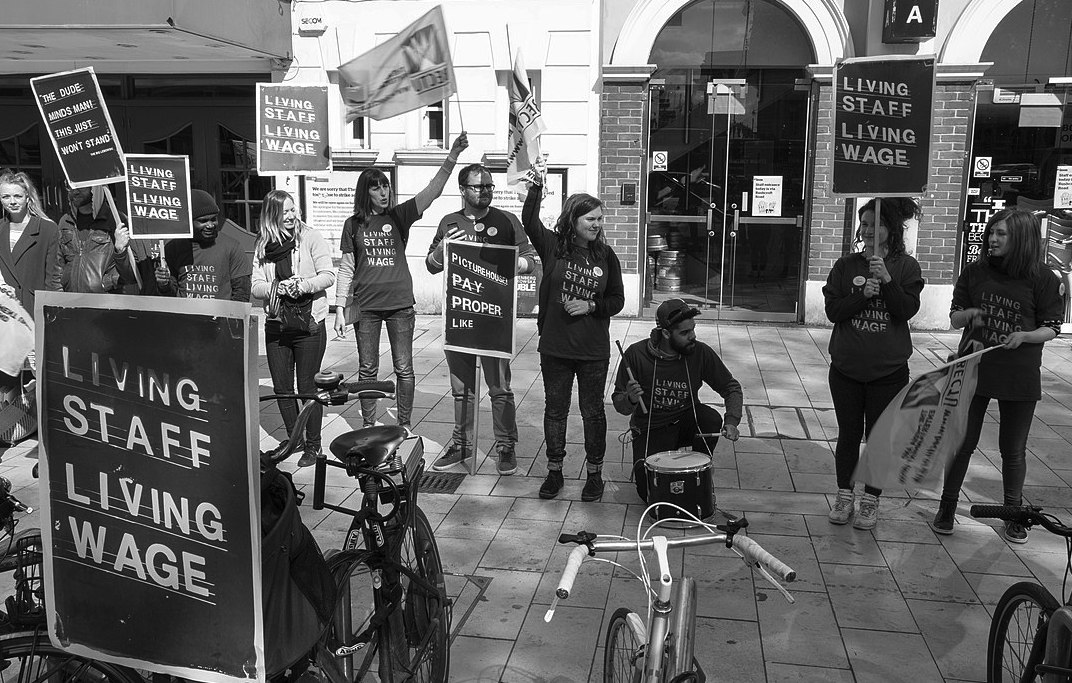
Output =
[{"x1": 941, "y1": 396, "x2": 1038, "y2": 505}]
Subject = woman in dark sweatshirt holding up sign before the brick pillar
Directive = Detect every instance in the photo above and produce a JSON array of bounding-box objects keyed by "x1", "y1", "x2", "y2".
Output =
[{"x1": 822, "y1": 197, "x2": 923, "y2": 531}]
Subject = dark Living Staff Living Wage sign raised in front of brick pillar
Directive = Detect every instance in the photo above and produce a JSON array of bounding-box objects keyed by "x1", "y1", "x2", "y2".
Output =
[{"x1": 833, "y1": 56, "x2": 935, "y2": 197}]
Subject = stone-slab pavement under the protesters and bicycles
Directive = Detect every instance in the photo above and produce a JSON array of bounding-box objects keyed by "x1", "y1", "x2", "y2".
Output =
[{"x1": 0, "y1": 316, "x2": 1072, "y2": 683}]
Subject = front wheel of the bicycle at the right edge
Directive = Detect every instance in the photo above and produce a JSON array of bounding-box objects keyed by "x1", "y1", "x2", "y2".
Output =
[{"x1": 986, "y1": 581, "x2": 1060, "y2": 683}]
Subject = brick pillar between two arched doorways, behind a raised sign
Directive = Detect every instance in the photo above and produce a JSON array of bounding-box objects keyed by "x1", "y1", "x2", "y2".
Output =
[{"x1": 808, "y1": 83, "x2": 972, "y2": 284}]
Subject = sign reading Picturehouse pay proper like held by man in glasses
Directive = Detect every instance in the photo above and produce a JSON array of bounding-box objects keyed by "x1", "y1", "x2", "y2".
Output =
[{"x1": 443, "y1": 239, "x2": 518, "y2": 358}]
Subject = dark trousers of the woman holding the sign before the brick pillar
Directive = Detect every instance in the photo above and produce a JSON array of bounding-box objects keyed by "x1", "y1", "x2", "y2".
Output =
[{"x1": 830, "y1": 363, "x2": 908, "y2": 495}]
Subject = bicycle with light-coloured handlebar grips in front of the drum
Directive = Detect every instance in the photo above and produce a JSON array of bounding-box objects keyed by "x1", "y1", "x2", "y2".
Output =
[{"x1": 544, "y1": 503, "x2": 796, "y2": 683}]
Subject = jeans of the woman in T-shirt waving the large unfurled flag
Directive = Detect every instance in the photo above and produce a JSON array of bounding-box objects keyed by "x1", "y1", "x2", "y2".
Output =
[{"x1": 354, "y1": 307, "x2": 416, "y2": 427}]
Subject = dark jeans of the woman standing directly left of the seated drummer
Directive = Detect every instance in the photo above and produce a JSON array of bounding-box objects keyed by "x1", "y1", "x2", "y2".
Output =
[{"x1": 539, "y1": 354, "x2": 610, "y2": 473}]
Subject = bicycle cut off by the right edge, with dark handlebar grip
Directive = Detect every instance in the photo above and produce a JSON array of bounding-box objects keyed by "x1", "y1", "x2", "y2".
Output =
[{"x1": 971, "y1": 505, "x2": 1072, "y2": 683}]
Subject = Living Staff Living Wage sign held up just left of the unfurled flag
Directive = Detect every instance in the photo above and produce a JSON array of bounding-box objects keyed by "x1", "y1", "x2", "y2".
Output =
[{"x1": 257, "y1": 83, "x2": 331, "y2": 175}]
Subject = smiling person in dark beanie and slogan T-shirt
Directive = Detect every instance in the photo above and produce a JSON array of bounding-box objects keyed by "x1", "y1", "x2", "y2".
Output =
[{"x1": 155, "y1": 190, "x2": 253, "y2": 301}]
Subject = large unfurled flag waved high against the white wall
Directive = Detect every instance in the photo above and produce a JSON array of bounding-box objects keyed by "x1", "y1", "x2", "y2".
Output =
[{"x1": 339, "y1": 5, "x2": 458, "y2": 123}]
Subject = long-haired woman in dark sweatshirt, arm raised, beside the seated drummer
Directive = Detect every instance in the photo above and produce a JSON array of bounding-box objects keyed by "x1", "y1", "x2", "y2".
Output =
[{"x1": 521, "y1": 183, "x2": 625, "y2": 501}]
